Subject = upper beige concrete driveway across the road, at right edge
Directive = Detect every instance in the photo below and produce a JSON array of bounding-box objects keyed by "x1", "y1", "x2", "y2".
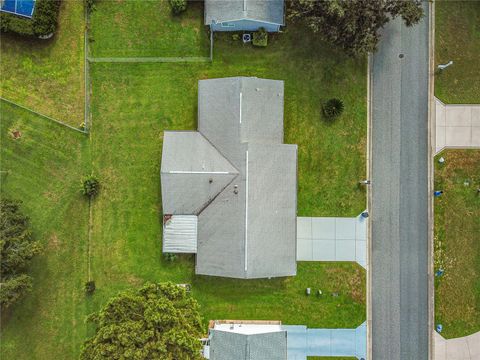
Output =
[{"x1": 432, "y1": 98, "x2": 480, "y2": 153}]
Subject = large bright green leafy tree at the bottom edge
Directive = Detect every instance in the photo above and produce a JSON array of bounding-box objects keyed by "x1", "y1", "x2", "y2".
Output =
[{"x1": 81, "y1": 283, "x2": 202, "y2": 360}]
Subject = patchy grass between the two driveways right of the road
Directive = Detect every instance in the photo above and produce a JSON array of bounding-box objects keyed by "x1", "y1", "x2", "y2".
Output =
[{"x1": 435, "y1": 150, "x2": 480, "y2": 338}]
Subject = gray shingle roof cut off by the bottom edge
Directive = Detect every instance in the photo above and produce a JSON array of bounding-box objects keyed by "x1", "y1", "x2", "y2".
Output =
[{"x1": 210, "y1": 330, "x2": 287, "y2": 360}]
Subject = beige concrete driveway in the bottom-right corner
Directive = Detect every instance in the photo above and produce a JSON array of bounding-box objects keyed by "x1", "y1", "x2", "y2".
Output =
[{"x1": 433, "y1": 331, "x2": 480, "y2": 360}]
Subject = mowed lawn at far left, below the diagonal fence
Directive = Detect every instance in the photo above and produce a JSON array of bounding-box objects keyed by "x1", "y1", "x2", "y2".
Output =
[{"x1": 0, "y1": 101, "x2": 88, "y2": 360}]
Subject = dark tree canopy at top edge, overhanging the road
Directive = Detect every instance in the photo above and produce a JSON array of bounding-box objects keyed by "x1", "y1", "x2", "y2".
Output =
[{"x1": 288, "y1": 0, "x2": 424, "y2": 56}]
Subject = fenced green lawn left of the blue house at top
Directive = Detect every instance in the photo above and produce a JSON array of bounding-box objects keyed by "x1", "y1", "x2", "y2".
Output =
[{"x1": 89, "y1": 0, "x2": 210, "y2": 57}]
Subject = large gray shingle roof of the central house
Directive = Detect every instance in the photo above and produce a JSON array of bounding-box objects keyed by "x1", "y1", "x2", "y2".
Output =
[{"x1": 161, "y1": 77, "x2": 297, "y2": 278}]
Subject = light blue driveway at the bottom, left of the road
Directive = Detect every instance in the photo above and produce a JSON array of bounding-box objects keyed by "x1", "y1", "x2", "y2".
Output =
[{"x1": 282, "y1": 322, "x2": 367, "y2": 360}]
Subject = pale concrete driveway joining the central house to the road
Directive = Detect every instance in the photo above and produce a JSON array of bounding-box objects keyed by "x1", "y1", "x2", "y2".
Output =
[{"x1": 297, "y1": 215, "x2": 367, "y2": 268}]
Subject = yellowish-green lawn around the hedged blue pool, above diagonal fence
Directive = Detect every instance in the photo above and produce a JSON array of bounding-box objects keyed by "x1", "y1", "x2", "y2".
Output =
[{"x1": 0, "y1": 1, "x2": 85, "y2": 126}]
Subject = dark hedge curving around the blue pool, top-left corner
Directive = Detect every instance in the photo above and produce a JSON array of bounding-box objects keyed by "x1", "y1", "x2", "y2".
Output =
[{"x1": 0, "y1": 0, "x2": 61, "y2": 36}]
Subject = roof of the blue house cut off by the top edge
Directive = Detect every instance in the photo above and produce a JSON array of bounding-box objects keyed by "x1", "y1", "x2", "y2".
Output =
[{"x1": 205, "y1": 0, "x2": 284, "y2": 25}]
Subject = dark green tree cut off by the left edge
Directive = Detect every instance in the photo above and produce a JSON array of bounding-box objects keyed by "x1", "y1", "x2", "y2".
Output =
[{"x1": 0, "y1": 198, "x2": 41, "y2": 310}]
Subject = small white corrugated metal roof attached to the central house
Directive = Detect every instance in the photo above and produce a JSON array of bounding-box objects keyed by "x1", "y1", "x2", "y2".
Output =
[{"x1": 163, "y1": 215, "x2": 197, "y2": 254}]
